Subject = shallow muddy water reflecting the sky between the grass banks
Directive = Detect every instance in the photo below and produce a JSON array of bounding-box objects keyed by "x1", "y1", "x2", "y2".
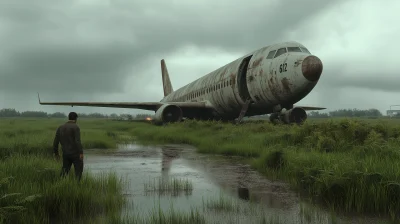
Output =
[{"x1": 85, "y1": 144, "x2": 388, "y2": 224}]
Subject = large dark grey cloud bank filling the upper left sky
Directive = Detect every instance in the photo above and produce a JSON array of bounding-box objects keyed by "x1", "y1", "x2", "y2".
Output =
[{"x1": 0, "y1": 0, "x2": 344, "y2": 94}]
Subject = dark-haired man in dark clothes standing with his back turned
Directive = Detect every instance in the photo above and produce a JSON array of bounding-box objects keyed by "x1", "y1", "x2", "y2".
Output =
[{"x1": 53, "y1": 112, "x2": 83, "y2": 181}]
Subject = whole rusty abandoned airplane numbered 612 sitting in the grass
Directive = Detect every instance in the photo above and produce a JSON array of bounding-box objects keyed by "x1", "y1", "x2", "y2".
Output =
[{"x1": 38, "y1": 41, "x2": 326, "y2": 124}]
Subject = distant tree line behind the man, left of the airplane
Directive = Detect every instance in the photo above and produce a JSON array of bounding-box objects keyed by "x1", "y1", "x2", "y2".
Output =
[{"x1": 0, "y1": 108, "x2": 153, "y2": 120}]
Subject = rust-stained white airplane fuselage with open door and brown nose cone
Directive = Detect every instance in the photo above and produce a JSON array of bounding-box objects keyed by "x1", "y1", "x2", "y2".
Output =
[{"x1": 161, "y1": 42, "x2": 322, "y2": 120}]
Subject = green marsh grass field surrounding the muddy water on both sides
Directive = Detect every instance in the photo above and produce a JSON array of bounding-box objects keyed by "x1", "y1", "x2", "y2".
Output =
[{"x1": 0, "y1": 119, "x2": 400, "y2": 221}]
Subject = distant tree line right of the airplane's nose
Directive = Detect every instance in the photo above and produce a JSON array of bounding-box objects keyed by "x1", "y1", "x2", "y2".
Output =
[{"x1": 308, "y1": 109, "x2": 383, "y2": 118}]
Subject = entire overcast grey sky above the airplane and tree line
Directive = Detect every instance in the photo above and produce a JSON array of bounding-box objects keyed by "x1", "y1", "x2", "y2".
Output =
[{"x1": 0, "y1": 0, "x2": 400, "y2": 113}]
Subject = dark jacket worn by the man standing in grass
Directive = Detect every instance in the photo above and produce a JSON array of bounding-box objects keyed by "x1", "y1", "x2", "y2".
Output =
[{"x1": 53, "y1": 121, "x2": 83, "y2": 155}]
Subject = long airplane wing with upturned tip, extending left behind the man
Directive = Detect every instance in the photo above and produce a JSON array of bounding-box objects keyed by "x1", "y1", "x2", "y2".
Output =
[{"x1": 38, "y1": 93, "x2": 209, "y2": 111}]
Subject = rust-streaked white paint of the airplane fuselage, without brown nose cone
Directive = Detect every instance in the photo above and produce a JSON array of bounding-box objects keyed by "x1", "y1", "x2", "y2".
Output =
[{"x1": 161, "y1": 42, "x2": 318, "y2": 120}]
